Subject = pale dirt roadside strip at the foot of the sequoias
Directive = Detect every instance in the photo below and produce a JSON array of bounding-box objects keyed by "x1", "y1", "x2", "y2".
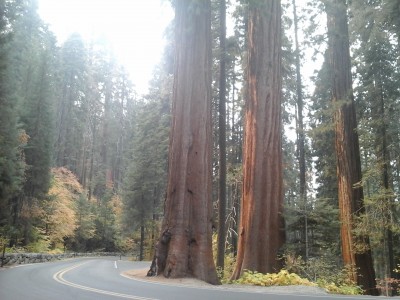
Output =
[{"x1": 123, "y1": 268, "x2": 328, "y2": 295}]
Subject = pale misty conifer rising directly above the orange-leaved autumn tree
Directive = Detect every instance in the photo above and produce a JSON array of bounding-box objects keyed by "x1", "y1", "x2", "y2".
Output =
[{"x1": 53, "y1": 34, "x2": 89, "y2": 174}]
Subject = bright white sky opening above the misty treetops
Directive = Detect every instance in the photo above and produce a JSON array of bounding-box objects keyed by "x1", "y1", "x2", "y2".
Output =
[{"x1": 38, "y1": 0, "x2": 174, "y2": 94}]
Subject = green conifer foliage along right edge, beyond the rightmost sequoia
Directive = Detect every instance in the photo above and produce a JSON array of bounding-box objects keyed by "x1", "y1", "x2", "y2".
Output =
[{"x1": 350, "y1": 1, "x2": 400, "y2": 294}]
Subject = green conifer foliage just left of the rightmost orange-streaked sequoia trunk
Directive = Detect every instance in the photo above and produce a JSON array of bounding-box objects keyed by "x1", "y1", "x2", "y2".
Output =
[{"x1": 310, "y1": 57, "x2": 340, "y2": 256}]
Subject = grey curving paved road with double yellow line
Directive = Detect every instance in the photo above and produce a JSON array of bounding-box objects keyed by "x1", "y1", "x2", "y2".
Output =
[{"x1": 0, "y1": 258, "x2": 393, "y2": 300}]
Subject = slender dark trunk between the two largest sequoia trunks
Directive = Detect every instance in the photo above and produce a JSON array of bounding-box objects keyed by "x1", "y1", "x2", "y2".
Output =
[{"x1": 217, "y1": 0, "x2": 226, "y2": 270}]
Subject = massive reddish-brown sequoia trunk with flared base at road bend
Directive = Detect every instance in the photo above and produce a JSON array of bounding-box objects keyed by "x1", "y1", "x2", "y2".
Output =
[{"x1": 148, "y1": 0, "x2": 219, "y2": 284}]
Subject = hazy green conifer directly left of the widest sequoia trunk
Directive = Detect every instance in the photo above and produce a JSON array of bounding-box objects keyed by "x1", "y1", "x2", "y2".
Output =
[{"x1": 122, "y1": 63, "x2": 172, "y2": 259}]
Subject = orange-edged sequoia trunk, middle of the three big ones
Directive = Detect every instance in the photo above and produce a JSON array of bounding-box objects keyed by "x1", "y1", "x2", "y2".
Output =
[{"x1": 232, "y1": 0, "x2": 284, "y2": 279}]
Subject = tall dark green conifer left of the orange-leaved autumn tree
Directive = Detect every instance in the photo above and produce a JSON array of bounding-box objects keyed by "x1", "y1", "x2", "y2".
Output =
[{"x1": 6, "y1": 1, "x2": 57, "y2": 245}]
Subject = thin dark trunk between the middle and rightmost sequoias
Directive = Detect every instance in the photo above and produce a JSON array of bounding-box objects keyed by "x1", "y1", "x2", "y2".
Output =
[{"x1": 292, "y1": 0, "x2": 308, "y2": 261}]
